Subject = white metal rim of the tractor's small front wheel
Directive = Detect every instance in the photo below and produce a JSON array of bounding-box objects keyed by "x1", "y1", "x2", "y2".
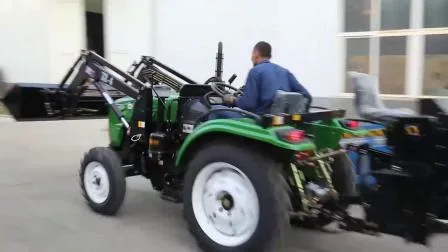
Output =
[{"x1": 84, "y1": 161, "x2": 110, "y2": 204}]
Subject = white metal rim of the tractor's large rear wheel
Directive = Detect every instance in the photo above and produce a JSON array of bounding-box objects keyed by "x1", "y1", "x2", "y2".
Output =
[{"x1": 192, "y1": 162, "x2": 260, "y2": 247}]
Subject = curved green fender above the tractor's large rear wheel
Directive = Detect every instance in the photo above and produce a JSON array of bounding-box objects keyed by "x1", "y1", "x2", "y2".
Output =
[{"x1": 175, "y1": 119, "x2": 316, "y2": 167}]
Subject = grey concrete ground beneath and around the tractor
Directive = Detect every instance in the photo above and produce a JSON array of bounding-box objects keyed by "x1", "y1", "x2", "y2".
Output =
[{"x1": 0, "y1": 118, "x2": 448, "y2": 252}]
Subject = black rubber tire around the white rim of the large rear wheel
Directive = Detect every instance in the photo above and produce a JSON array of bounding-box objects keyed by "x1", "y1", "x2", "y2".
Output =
[{"x1": 184, "y1": 141, "x2": 291, "y2": 252}]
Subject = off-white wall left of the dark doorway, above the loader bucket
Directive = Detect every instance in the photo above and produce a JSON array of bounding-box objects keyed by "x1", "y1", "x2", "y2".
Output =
[{"x1": 0, "y1": 0, "x2": 85, "y2": 83}]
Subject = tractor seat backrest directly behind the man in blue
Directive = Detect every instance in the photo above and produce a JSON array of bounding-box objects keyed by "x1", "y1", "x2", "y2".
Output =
[{"x1": 270, "y1": 90, "x2": 308, "y2": 115}]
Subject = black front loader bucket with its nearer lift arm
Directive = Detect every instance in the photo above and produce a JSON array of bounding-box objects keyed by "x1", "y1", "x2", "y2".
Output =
[{"x1": 0, "y1": 51, "x2": 144, "y2": 121}]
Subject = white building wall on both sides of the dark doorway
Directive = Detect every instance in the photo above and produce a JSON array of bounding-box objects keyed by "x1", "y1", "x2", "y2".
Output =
[{"x1": 0, "y1": 0, "x2": 344, "y2": 96}]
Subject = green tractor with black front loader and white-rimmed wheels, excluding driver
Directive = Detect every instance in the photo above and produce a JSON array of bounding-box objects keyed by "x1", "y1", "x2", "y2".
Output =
[{"x1": 2, "y1": 44, "x2": 446, "y2": 251}]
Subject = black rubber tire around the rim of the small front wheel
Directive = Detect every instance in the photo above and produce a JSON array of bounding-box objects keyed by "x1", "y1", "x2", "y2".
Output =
[{"x1": 79, "y1": 147, "x2": 126, "y2": 215}]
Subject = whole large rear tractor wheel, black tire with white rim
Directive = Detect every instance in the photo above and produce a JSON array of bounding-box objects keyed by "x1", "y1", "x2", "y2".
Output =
[{"x1": 184, "y1": 142, "x2": 290, "y2": 252}]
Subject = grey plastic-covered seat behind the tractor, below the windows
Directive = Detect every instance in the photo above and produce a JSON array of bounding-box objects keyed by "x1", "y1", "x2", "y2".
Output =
[{"x1": 348, "y1": 72, "x2": 416, "y2": 124}]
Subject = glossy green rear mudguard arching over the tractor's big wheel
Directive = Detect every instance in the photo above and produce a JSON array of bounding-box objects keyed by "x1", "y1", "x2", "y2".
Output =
[{"x1": 175, "y1": 119, "x2": 315, "y2": 172}]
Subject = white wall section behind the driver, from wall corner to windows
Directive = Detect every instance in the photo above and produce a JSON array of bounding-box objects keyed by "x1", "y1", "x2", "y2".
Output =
[{"x1": 155, "y1": 0, "x2": 344, "y2": 96}]
